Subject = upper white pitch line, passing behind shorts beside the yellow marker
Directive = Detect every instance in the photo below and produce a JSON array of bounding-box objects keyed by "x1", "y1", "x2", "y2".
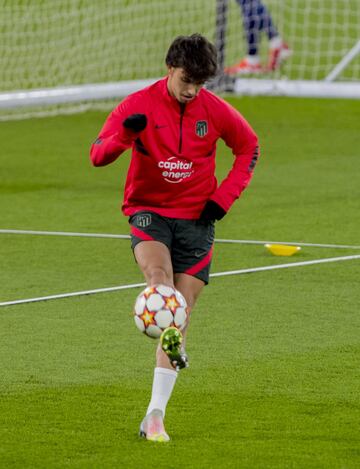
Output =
[{"x1": 0, "y1": 229, "x2": 360, "y2": 249}]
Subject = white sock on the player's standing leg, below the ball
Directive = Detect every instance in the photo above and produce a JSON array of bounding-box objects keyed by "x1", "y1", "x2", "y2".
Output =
[{"x1": 146, "y1": 368, "x2": 177, "y2": 417}]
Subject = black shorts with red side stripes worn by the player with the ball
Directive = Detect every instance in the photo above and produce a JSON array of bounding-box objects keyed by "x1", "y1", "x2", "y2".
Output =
[{"x1": 129, "y1": 211, "x2": 215, "y2": 285}]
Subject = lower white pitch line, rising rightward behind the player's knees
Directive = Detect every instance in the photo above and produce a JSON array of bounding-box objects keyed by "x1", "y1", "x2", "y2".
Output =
[{"x1": 0, "y1": 254, "x2": 360, "y2": 307}]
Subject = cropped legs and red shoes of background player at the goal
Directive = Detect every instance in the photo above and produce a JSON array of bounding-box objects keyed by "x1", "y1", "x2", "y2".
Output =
[{"x1": 225, "y1": 0, "x2": 292, "y2": 75}]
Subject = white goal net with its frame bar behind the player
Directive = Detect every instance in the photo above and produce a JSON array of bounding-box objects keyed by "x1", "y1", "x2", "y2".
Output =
[{"x1": 0, "y1": 0, "x2": 360, "y2": 120}]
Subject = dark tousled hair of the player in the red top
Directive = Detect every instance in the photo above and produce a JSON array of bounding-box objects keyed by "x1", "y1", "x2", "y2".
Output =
[{"x1": 165, "y1": 34, "x2": 217, "y2": 83}]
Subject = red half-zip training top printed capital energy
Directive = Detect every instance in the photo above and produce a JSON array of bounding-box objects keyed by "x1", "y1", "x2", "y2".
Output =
[{"x1": 90, "y1": 78, "x2": 259, "y2": 219}]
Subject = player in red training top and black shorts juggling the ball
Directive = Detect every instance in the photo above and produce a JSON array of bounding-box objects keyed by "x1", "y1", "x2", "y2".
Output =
[{"x1": 90, "y1": 34, "x2": 259, "y2": 441}]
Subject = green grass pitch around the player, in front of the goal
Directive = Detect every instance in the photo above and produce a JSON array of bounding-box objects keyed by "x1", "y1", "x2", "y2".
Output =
[{"x1": 0, "y1": 98, "x2": 360, "y2": 469}]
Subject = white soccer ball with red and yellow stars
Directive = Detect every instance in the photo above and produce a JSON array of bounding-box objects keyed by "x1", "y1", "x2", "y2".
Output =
[{"x1": 134, "y1": 285, "x2": 187, "y2": 338}]
